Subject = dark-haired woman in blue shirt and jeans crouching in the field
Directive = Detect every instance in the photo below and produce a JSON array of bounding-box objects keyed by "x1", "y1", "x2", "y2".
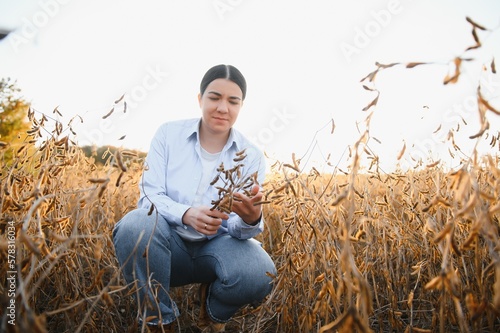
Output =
[{"x1": 113, "y1": 65, "x2": 275, "y2": 332}]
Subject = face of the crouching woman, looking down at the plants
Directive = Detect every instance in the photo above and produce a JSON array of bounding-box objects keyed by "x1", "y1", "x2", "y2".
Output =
[{"x1": 198, "y1": 79, "x2": 243, "y2": 134}]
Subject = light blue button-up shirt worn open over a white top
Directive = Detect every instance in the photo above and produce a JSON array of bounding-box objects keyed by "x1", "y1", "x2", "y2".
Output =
[{"x1": 138, "y1": 118, "x2": 266, "y2": 239}]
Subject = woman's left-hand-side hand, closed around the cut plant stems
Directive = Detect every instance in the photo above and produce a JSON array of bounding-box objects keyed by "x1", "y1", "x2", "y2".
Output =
[{"x1": 182, "y1": 206, "x2": 229, "y2": 236}]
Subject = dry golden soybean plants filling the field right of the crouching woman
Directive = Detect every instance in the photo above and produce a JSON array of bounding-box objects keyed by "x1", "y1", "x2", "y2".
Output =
[{"x1": 262, "y1": 152, "x2": 500, "y2": 332}]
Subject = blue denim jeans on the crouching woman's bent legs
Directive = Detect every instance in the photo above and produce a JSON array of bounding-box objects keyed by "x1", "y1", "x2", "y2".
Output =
[{"x1": 113, "y1": 209, "x2": 276, "y2": 324}]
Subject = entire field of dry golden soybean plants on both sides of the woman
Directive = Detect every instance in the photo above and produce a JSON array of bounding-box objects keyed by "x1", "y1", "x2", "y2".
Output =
[{"x1": 0, "y1": 105, "x2": 500, "y2": 332}]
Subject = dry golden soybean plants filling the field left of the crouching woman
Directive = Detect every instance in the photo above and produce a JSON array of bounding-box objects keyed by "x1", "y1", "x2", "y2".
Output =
[{"x1": 1, "y1": 110, "x2": 141, "y2": 332}]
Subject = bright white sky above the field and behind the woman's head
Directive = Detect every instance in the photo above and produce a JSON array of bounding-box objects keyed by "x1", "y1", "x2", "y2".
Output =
[{"x1": 0, "y1": 0, "x2": 500, "y2": 171}]
